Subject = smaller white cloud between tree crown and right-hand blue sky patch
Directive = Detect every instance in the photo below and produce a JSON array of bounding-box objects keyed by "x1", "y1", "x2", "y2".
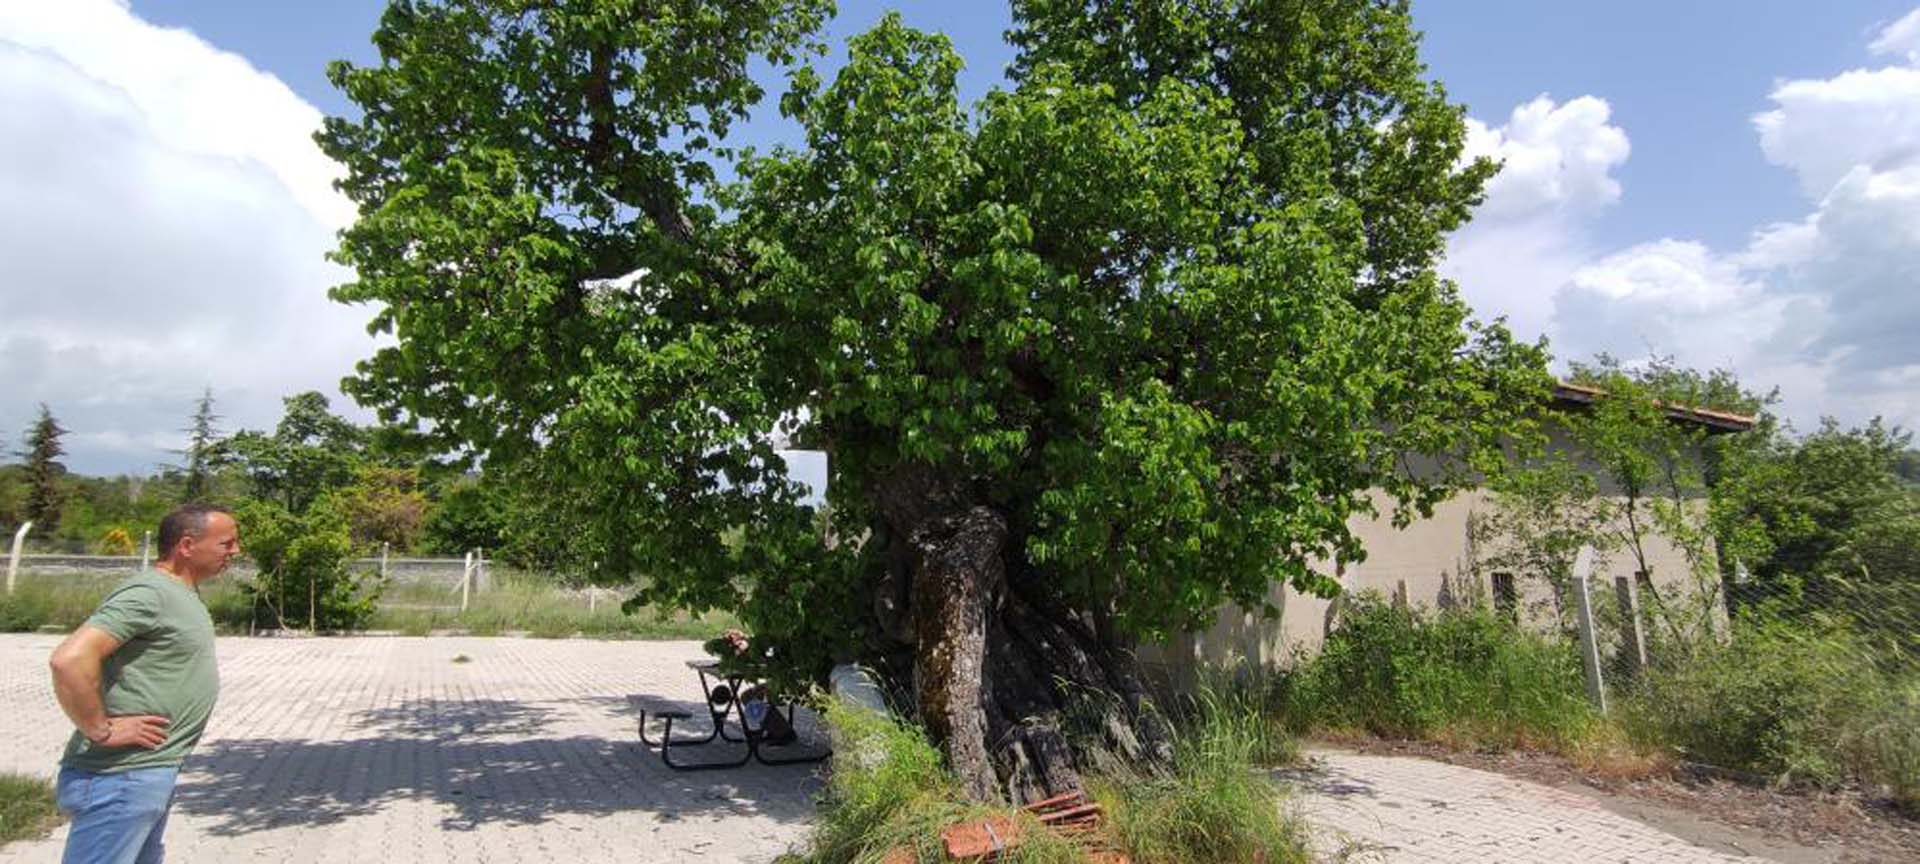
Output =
[{"x1": 1442, "y1": 94, "x2": 1632, "y2": 338}]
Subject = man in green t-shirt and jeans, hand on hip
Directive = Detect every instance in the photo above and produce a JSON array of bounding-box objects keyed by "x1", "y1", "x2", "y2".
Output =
[{"x1": 48, "y1": 505, "x2": 240, "y2": 864}]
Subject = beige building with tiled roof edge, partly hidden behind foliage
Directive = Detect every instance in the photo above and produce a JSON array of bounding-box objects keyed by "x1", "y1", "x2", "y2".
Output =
[{"x1": 1142, "y1": 384, "x2": 1753, "y2": 678}]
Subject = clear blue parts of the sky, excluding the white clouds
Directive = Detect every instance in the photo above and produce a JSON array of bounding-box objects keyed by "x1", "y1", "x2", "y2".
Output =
[{"x1": 132, "y1": 0, "x2": 1912, "y2": 257}]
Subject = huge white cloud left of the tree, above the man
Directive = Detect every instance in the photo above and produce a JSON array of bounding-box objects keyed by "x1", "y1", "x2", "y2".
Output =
[{"x1": 0, "y1": 0, "x2": 372, "y2": 470}]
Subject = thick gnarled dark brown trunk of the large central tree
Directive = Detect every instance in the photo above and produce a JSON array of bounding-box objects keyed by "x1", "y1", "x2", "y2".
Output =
[{"x1": 876, "y1": 466, "x2": 1171, "y2": 803}]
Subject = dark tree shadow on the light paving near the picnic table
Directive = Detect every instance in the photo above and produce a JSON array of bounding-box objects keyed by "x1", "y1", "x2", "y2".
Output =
[{"x1": 175, "y1": 695, "x2": 820, "y2": 835}]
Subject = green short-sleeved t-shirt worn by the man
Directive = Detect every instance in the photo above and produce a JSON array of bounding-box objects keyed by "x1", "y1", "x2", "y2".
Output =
[{"x1": 60, "y1": 570, "x2": 221, "y2": 774}]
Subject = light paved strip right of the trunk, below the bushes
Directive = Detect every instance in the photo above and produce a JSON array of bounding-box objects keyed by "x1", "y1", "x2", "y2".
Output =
[{"x1": 1283, "y1": 749, "x2": 1755, "y2": 864}]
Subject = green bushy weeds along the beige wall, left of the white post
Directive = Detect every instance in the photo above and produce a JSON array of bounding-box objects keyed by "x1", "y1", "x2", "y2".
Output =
[{"x1": 1281, "y1": 593, "x2": 1597, "y2": 749}]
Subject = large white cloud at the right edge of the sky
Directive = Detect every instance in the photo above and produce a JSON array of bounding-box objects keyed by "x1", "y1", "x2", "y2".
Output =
[{"x1": 1528, "y1": 12, "x2": 1920, "y2": 428}]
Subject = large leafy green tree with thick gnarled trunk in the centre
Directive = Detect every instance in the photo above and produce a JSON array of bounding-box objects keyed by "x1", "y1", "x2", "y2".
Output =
[{"x1": 321, "y1": 0, "x2": 1544, "y2": 799}]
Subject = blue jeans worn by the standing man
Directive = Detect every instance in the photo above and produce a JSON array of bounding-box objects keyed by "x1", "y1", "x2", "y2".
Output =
[{"x1": 56, "y1": 766, "x2": 180, "y2": 864}]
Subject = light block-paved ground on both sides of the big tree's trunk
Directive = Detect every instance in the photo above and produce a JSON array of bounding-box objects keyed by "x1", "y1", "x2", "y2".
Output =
[{"x1": 0, "y1": 636, "x2": 1812, "y2": 864}]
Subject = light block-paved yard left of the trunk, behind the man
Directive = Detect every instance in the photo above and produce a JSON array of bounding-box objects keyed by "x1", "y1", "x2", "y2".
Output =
[{"x1": 0, "y1": 636, "x2": 818, "y2": 862}]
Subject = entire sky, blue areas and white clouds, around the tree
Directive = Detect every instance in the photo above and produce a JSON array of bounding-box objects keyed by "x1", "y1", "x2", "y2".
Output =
[{"x1": 0, "y1": 0, "x2": 1920, "y2": 470}]
